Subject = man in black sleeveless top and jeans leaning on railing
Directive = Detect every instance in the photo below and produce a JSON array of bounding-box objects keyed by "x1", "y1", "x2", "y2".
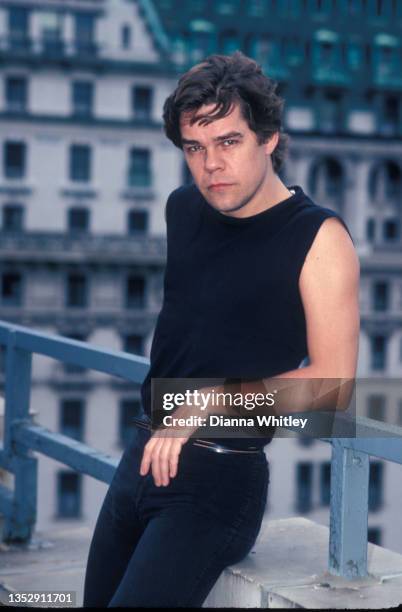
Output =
[{"x1": 84, "y1": 52, "x2": 359, "y2": 607}]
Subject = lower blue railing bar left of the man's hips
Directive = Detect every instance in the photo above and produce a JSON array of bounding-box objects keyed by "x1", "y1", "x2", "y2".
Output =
[{"x1": 14, "y1": 422, "x2": 119, "y2": 483}]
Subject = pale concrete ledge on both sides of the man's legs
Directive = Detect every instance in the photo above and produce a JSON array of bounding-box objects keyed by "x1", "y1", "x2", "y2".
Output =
[{"x1": 0, "y1": 518, "x2": 402, "y2": 610}]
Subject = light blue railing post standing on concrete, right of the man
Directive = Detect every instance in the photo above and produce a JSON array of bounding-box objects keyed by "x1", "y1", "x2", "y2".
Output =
[{"x1": 329, "y1": 439, "x2": 369, "y2": 579}]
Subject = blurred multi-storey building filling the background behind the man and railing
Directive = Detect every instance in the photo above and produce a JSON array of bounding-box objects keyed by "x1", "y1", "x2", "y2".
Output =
[{"x1": 0, "y1": 0, "x2": 402, "y2": 551}]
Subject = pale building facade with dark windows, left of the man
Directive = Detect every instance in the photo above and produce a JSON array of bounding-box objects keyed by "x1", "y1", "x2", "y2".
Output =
[{"x1": 0, "y1": 0, "x2": 182, "y2": 528}]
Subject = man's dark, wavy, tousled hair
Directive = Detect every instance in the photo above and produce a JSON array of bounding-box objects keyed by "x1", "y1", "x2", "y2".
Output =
[{"x1": 163, "y1": 51, "x2": 289, "y2": 172}]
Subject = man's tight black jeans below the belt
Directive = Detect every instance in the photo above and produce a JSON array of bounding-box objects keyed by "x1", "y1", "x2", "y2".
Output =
[{"x1": 84, "y1": 429, "x2": 269, "y2": 607}]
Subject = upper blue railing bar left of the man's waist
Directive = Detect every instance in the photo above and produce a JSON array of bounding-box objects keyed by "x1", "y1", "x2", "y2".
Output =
[{"x1": 0, "y1": 323, "x2": 149, "y2": 383}]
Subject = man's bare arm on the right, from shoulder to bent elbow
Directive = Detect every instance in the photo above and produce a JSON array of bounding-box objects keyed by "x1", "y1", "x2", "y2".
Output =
[{"x1": 264, "y1": 218, "x2": 360, "y2": 413}]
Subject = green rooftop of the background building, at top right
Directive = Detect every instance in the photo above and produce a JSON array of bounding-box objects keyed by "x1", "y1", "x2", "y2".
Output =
[{"x1": 154, "y1": 0, "x2": 402, "y2": 136}]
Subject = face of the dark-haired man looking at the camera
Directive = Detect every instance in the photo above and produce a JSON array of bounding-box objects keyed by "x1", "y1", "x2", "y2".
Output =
[{"x1": 180, "y1": 104, "x2": 277, "y2": 216}]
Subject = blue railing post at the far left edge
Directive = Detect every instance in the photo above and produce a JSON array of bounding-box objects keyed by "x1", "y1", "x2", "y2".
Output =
[{"x1": 3, "y1": 330, "x2": 38, "y2": 542}]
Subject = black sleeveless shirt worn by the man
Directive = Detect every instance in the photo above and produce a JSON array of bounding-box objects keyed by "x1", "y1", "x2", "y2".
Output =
[{"x1": 141, "y1": 185, "x2": 350, "y2": 448}]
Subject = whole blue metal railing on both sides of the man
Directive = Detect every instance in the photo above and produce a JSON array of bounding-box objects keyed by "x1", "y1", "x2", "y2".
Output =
[{"x1": 0, "y1": 322, "x2": 402, "y2": 579}]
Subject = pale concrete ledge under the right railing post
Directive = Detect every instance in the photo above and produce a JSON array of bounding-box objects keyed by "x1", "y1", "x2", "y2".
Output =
[{"x1": 204, "y1": 518, "x2": 402, "y2": 609}]
